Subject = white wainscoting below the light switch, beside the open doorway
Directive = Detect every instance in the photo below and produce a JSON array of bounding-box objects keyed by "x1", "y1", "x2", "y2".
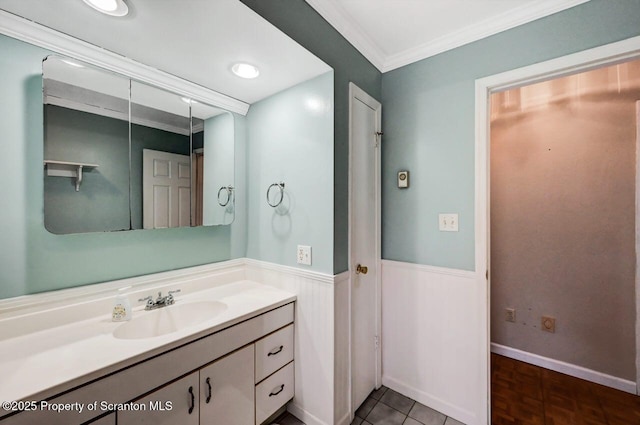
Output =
[{"x1": 382, "y1": 260, "x2": 488, "y2": 425}]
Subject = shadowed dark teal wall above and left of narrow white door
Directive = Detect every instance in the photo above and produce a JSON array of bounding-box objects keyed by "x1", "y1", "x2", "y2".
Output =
[{"x1": 241, "y1": 0, "x2": 384, "y2": 274}]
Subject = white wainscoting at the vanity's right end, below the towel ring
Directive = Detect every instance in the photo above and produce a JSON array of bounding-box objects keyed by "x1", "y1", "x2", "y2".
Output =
[{"x1": 245, "y1": 259, "x2": 338, "y2": 425}]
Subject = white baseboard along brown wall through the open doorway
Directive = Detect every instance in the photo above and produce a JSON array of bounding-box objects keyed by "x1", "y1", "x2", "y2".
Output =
[{"x1": 491, "y1": 342, "x2": 637, "y2": 394}]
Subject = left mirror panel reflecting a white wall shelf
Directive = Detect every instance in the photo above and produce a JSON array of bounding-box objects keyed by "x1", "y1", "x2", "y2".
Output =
[{"x1": 43, "y1": 56, "x2": 130, "y2": 234}]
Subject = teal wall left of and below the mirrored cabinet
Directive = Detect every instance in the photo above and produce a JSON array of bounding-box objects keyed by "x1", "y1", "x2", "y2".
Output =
[{"x1": 0, "y1": 36, "x2": 231, "y2": 298}]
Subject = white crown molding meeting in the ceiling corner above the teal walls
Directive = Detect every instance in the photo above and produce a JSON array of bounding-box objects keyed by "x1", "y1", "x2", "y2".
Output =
[{"x1": 306, "y1": 0, "x2": 590, "y2": 73}]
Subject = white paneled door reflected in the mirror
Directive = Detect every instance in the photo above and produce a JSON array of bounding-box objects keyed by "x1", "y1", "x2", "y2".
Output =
[{"x1": 142, "y1": 149, "x2": 191, "y2": 229}]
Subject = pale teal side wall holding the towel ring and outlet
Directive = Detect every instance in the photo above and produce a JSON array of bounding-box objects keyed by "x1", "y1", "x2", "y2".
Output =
[{"x1": 246, "y1": 72, "x2": 333, "y2": 274}]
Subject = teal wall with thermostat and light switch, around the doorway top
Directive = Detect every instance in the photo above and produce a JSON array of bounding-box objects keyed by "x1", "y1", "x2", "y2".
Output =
[{"x1": 382, "y1": 0, "x2": 640, "y2": 270}]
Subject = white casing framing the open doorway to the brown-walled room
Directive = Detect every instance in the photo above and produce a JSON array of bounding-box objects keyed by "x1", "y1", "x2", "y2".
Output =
[{"x1": 475, "y1": 37, "x2": 640, "y2": 424}]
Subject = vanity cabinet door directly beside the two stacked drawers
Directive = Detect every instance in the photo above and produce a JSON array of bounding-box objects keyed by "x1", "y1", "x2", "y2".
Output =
[{"x1": 200, "y1": 344, "x2": 255, "y2": 425}]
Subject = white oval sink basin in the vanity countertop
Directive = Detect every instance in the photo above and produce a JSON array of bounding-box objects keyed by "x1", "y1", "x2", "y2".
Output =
[{"x1": 113, "y1": 301, "x2": 227, "y2": 339}]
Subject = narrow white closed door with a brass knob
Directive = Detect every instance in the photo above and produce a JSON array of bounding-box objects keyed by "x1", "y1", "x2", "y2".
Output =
[{"x1": 349, "y1": 83, "x2": 382, "y2": 413}]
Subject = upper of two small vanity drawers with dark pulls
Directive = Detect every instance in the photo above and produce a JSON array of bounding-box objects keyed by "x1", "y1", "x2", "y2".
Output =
[{"x1": 256, "y1": 324, "x2": 293, "y2": 384}]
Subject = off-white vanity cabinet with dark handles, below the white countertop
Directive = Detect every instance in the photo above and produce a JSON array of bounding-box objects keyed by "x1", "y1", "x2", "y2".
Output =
[{"x1": 0, "y1": 302, "x2": 294, "y2": 425}]
